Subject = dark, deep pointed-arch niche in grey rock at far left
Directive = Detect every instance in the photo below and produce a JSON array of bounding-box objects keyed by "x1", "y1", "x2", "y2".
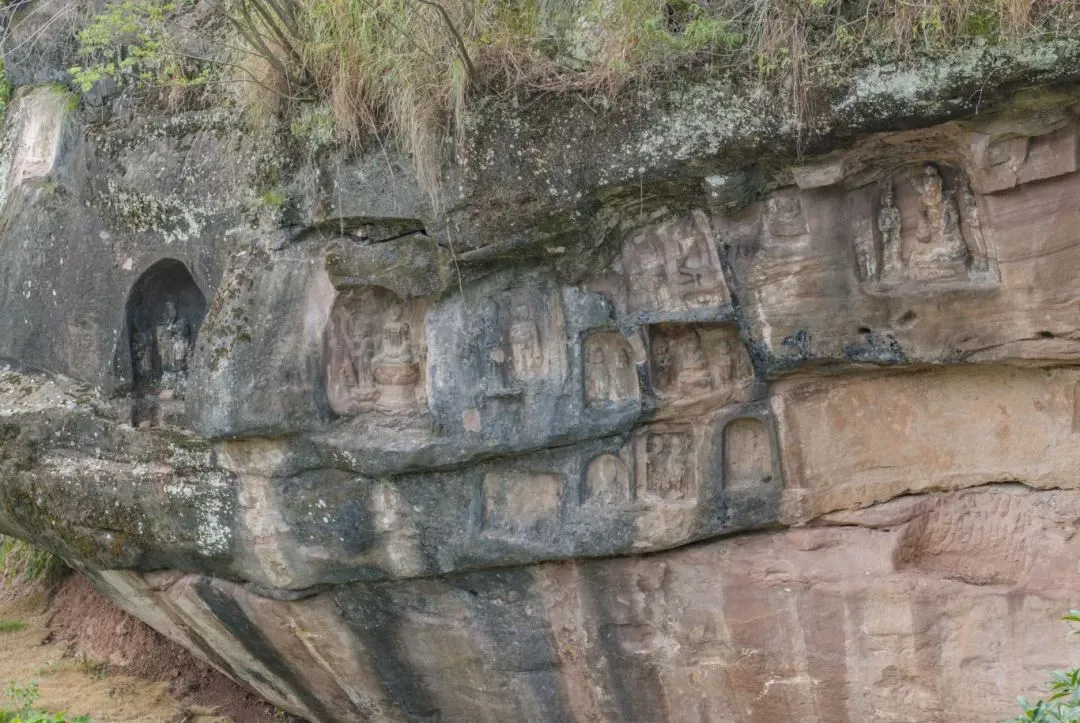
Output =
[{"x1": 126, "y1": 258, "x2": 206, "y2": 426}]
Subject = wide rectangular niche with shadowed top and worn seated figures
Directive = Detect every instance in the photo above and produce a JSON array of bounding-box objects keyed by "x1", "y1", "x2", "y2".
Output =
[{"x1": 649, "y1": 324, "x2": 753, "y2": 403}]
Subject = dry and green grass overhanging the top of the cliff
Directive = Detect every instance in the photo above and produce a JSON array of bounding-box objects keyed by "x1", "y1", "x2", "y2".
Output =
[{"x1": 61, "y1": 0, "x2": 1080, "y2": 194}]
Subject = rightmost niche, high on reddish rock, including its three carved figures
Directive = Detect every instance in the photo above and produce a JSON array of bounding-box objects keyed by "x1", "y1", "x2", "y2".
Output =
[{"x1": 853, "y1": 164, "x2": 996, "y2": 292}]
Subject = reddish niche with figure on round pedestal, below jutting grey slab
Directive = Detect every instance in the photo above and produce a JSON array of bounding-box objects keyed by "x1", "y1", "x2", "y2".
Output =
[{"x1": 326, "y1": 286, "x2": 428, "y2": 416}]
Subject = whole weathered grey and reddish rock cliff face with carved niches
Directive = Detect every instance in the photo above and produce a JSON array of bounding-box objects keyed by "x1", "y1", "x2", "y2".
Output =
[{"x1": 6, "y1": 21, "x2": 1080, "y2": 721}]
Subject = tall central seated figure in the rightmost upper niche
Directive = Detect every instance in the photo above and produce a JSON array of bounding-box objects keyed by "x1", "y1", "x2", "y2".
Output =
[{"x1": 907, "y1": 164, "x2": 968, "y2": 279}]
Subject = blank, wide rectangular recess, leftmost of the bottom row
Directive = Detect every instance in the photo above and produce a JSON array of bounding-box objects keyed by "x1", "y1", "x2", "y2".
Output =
[{"x1": 483, "y1": 470, "x2": 564, "y2": 534}]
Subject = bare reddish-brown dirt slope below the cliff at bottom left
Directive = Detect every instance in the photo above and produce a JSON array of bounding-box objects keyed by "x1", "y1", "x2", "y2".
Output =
[{"x1": 0, "y1": 575, "x2": 299, "y2": 723}]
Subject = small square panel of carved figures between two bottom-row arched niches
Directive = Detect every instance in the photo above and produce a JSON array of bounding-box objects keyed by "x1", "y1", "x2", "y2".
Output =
[{"x1": 636, "y1": 425, "x2": 699, "y2": 503}]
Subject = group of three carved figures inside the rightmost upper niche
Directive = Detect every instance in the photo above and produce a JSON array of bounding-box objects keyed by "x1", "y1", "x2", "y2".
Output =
[{"x1": 855, "y1": 164, "x2": 989, "y2": 282}]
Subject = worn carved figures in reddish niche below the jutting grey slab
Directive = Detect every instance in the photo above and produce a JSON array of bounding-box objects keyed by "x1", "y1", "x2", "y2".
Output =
[{"x1": 330, "y1": 302, "x2": 420, "y2": 414}]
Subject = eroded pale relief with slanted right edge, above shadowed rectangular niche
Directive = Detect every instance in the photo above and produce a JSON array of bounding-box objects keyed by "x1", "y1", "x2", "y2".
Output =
[{"x1": 590, "y1": 205, "x2": 731, "y2": 316}]
